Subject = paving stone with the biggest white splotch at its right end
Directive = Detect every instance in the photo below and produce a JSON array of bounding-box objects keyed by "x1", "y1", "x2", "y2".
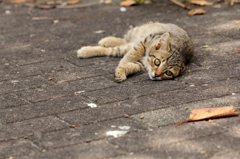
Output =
[{"x1": 29, "y1": 118, "x2": 145, "y2": 149}]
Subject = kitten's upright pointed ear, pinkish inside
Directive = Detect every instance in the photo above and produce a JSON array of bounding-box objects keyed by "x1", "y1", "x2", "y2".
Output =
[{"x1": 156, "y1": 32, "x2": 170, "y2": 51}]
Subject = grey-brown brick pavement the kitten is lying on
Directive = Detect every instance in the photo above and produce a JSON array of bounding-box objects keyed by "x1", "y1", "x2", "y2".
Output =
[{"x1": 0, "y1": 1, "x2": 240, "y2": 159}]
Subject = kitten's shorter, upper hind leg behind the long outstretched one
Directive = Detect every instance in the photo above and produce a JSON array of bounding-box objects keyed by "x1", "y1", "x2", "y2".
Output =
[{"x1": 98, "y1": 36, "x2": 126, "y2": 47}]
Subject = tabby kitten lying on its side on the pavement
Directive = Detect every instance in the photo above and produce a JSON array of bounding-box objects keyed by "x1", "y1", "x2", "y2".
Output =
[{"x1": 77, "y1": 22, "x2": 193, "y2": 82}]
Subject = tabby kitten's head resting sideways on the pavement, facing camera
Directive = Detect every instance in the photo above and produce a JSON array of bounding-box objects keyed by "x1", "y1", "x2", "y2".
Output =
[{"x1": 145, "y1": 33, "x2": 185, "y2": 80}]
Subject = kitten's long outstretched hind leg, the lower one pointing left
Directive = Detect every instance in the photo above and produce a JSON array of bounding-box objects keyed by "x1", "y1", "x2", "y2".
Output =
[{"x1": 77, "y1": 44, "x2": 131, "y2": 58}]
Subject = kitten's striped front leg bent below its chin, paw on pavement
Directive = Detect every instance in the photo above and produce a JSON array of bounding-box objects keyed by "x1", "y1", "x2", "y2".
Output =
[{"x1": 115, "y1": 62, "x2": 145, "y2": 82}]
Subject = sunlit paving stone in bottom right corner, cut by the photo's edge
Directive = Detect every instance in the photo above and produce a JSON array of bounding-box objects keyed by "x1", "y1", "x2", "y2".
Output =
[{"x1": 112, "y1": 133, "x2": 239, "y2": 158}]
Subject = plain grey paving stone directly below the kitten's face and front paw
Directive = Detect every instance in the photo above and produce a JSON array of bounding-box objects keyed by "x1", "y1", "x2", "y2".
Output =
[{"x1": 80, "y1": 79, "x2": 183, "y2": 104}]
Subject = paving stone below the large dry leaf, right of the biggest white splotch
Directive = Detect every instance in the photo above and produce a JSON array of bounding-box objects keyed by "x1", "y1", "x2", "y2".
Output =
[{"x1": 109, "y1": 121, "x2": 227, "y2": 152}]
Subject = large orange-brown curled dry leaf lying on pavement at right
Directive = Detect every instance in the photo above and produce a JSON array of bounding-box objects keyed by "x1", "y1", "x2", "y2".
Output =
[{"x1": 175, "y1": 106, "x2": 238, "y2": 126}]
